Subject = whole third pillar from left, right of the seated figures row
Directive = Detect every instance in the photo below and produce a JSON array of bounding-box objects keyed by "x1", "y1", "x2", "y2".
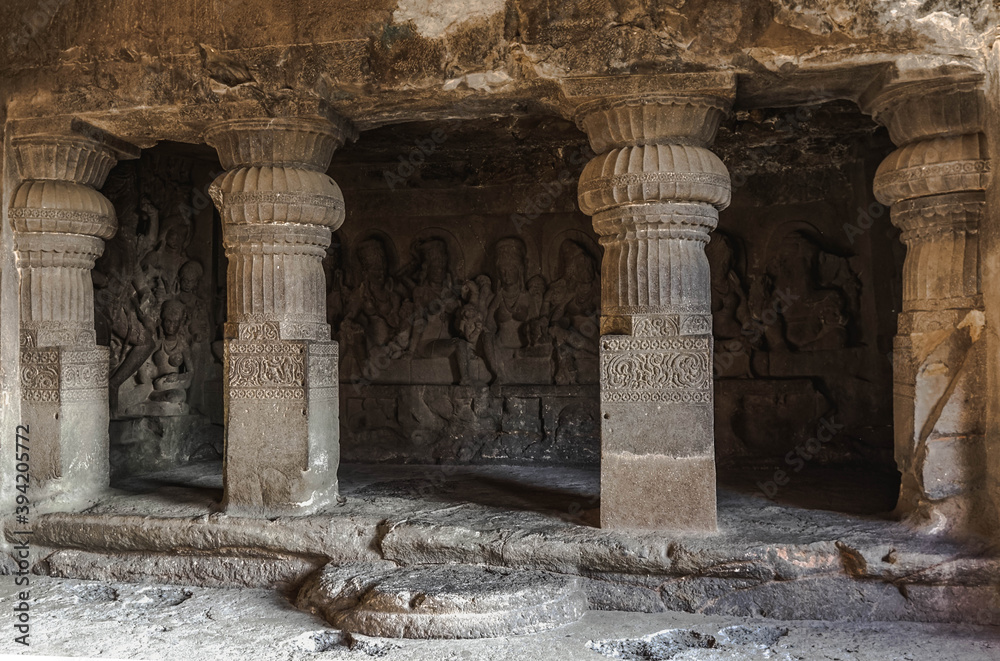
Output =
[{"x1": 564, "y1": 74, "x2": 735, "y2": 531}]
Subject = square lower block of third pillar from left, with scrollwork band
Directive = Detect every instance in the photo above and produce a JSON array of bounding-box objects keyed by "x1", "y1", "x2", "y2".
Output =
[{"x1": 601, "y1": 336, "x2": 716, "y2": 532}]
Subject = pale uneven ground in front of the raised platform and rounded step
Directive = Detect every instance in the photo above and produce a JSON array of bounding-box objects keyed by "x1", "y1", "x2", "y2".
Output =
[{"x1": 0, "y1": 577, "x2": 1000, "y2": 661}]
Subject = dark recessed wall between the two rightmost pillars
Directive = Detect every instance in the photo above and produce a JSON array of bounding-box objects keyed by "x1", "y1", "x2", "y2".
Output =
[{"x1": 709, "y1": 102, "x2": 904, "y2": 471}]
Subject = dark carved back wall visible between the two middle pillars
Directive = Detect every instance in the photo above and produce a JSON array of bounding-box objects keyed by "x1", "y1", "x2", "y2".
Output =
[{"x1": 328, "y1": 118, "x2": 601, "y2": 464}]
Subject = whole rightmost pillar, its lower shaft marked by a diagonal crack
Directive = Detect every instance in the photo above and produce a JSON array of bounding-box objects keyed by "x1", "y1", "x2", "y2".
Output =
[{"x1": 869, "y1": 78, "x2": 990, "y2": 532}]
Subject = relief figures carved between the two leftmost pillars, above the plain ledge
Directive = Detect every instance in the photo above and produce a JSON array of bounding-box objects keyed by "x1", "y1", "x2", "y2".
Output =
[{"x1": 94, "y1": 153, "x2": 217, "y2": 418}]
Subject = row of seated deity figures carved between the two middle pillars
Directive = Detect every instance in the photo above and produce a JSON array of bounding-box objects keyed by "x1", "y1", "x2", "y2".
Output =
[{"x1": 336, "y1": 234, "x2": 600, "y2": 386}]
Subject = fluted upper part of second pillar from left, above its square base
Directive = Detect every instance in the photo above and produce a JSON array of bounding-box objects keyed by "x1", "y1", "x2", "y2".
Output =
[{"x1": 205, "y1": 117, "x2": 357, "y2": 340}]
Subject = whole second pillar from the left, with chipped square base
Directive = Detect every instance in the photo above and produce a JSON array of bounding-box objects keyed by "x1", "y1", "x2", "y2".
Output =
[{"x1": 206, "y1": 118, "x2": 354, "y2": 515}]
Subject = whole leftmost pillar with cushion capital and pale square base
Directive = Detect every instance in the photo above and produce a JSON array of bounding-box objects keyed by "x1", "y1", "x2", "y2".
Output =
[{"x1": 8, "y1": 125, "x2": 138, "y2": 509}]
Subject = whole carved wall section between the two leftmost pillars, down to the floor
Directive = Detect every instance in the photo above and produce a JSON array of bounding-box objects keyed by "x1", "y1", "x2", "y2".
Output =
[{"x1": 93, "y1": 149, "x2": 225, "y2": 475}]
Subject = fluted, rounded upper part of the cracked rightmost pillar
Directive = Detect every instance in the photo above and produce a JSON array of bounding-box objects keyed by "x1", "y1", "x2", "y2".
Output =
[{"x1": 867, "y1": 76, "x2": 991, "y2": 312}]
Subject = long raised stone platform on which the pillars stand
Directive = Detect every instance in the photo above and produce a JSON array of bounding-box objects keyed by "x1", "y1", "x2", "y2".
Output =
[{"x1": 7, "y1": 464, "x2": 1000, "y2": 624}]
